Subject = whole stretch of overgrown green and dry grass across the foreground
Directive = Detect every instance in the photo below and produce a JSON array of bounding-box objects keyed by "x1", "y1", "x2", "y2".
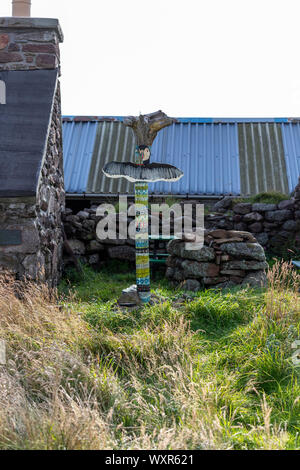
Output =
[{"x1": 0, "y1": 262, "x2": 300, "y2": 449}]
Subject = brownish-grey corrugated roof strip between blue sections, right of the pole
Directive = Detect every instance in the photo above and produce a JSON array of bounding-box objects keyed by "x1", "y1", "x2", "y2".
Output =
[{"x1": 238, "y1": 123, "x2": 289, "y2": 196}]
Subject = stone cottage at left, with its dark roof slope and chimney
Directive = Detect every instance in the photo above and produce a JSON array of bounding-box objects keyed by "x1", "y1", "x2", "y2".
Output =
[{"x1": 0, "y1": 14, "x2": 65, "y2": 286}]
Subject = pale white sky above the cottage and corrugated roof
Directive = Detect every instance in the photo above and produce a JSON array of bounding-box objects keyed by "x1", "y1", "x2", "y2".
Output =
[{"x1": 0, "y1": 0, "x2": 300, "y2": 117}]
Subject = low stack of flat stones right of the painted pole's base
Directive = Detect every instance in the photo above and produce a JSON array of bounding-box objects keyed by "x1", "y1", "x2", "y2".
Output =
[{"x1": 166, "y1": 229, "x2": 268, "y2": 291}]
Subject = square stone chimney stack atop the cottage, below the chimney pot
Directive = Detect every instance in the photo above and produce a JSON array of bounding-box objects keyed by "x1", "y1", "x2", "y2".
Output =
[{"x1": 0, "y1": 18, "x2": 63, "y2": 70}]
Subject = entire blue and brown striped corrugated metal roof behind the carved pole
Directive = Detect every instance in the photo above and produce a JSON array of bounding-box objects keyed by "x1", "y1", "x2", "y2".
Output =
[{"x1": 63, "y1": 116, "x2": 300, "y2": 199}]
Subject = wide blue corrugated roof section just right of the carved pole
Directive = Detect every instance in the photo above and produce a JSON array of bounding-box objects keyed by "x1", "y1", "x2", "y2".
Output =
[{"x1": 149, "y1": 123, "x2": 240, "y2": 195}]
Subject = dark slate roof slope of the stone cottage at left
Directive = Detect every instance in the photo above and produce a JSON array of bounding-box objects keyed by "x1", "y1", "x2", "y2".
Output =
[{"x1": 0, "y1": 70, "x2": 58, "y2": 197}]
